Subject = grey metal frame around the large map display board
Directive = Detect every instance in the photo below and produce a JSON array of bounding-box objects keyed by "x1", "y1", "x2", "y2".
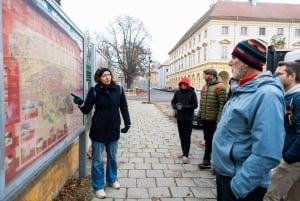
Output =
[{"x1": 0, "y1": 0, "x2": 86, "y2": 201}]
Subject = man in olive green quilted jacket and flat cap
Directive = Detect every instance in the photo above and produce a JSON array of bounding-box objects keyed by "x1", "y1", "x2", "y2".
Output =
[{"x1": 198, "y1": 69, "x2": 226, "y2": 169}]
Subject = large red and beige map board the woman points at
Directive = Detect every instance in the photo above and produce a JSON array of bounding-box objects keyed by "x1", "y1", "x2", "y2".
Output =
[{"x1": 2, "y1": 0, "x2": 84, "y2": 183}]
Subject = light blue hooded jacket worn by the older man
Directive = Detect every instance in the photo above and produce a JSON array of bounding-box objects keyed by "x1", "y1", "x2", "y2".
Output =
[{"x1": 212, "y1": 72, "x2": 285, "y2": 199}]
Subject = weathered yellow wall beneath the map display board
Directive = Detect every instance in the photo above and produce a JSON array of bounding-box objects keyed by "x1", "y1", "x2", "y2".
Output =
[{"x1": 11, "y1": 141, "x2": 79, "y2": 201}]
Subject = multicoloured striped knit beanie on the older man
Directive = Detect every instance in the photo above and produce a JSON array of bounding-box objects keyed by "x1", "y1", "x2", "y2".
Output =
[{"x1": 231, "y1": 39, "x2": 267, "y2": 71}]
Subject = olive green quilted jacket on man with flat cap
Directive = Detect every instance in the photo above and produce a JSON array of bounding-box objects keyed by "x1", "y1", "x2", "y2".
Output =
[{"x1": 198, "y1": 78, "x2": 226, "y2": 122}]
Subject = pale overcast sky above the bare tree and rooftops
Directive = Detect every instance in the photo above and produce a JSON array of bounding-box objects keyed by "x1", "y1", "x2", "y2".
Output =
[{"x1": 61, "y1": 0, "x2": 300, "y2": 63}]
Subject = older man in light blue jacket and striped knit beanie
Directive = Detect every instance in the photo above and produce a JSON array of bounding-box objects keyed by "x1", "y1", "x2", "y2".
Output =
[{"x1": 212, "y1": 39, "x2": 285, "y2": 201}]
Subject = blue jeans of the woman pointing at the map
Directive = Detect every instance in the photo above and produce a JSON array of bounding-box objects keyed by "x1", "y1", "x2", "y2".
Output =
[{"x1": 91, "y1": 140, "x2": 118, "y2": 190}]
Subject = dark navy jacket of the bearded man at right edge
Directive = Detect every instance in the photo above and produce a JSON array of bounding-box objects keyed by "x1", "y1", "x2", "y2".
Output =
[{"x1": 283, "y1": 84, "x2": 300, "y2": 164}]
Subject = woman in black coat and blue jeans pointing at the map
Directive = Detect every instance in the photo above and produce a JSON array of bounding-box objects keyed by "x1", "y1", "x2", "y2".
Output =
[{"x1": 72, "y1": 68, "x2": 131, "y2": 198}]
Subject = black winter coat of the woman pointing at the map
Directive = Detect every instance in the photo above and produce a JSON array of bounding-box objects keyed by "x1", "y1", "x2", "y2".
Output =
[{"x1": 80, "y1": 84, "x2": 131, "y2": 142}]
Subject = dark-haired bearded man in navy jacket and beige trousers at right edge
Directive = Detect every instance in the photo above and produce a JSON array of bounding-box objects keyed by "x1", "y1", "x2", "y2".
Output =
[{"x1": 264, "y1": 62, "x2": 300, "y2": 201}]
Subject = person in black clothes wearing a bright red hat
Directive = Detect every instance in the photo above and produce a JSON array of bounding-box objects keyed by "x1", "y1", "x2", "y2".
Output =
[{"x1": 171, "y1": 77, "x2": 198, "y2": 164}]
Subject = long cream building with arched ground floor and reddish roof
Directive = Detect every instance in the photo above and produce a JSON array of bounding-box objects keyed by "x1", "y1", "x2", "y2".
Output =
[{"x1": 168, "y1": 0, "x2": 300, "y2": 90}]
